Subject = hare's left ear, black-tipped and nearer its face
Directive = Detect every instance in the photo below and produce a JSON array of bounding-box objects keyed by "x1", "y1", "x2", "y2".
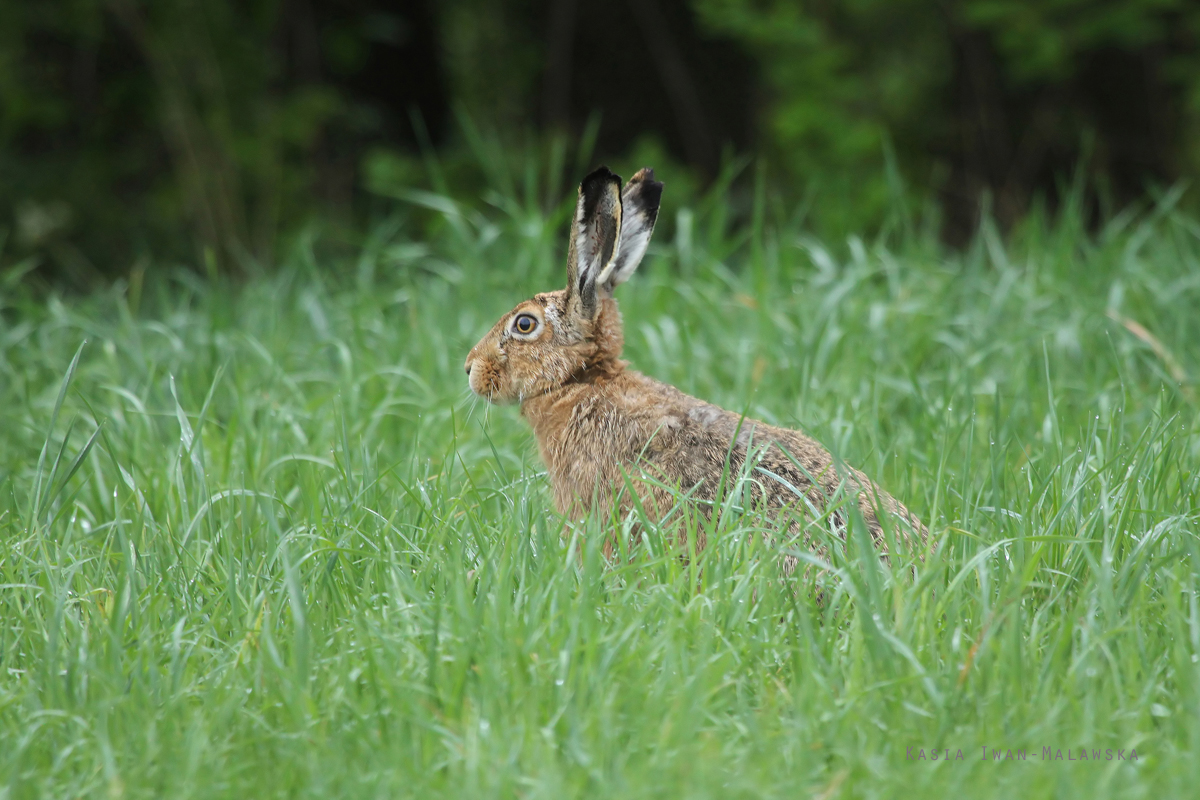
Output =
[{"x1": 566, "y1": 167, "x2": 622, "y2": 319}]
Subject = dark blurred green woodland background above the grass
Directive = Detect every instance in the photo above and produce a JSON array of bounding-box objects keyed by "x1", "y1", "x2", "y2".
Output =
[{"x1": 0, "y1": 0, "x2": 1200, "y2": 284}]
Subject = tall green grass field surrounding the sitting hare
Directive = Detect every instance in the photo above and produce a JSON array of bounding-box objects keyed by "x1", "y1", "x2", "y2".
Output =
[{"x1": 0, "y1": 165, "x2": 1200, "y2": 798}]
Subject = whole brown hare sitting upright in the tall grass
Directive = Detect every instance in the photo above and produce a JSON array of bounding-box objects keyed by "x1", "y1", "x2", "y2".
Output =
[{"x1": 466, "y1": 167, "x2": 928, "y2": 561}]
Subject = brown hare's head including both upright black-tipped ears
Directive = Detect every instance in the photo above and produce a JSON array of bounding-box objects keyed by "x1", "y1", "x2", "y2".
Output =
[{"x1": 466, "y1": 167, "x2": 662, "y2": 403}]
